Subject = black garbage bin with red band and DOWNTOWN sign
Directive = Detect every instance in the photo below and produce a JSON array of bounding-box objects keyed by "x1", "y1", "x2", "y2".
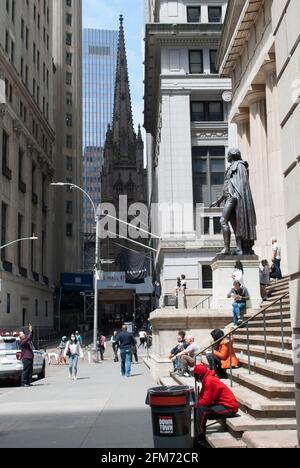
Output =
[{"x1": 146, "y1": 385, "x2": 195, "y2": 448}]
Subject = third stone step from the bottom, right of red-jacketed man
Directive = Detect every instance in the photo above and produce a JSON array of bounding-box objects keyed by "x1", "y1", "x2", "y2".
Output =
[{"x1": 232, "y1": 383, "x2": 296, "y2": 419}]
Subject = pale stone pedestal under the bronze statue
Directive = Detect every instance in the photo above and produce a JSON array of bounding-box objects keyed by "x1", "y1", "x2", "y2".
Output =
[{"x1": 211, "y1": 255, "x2": 261, "y2": 310}]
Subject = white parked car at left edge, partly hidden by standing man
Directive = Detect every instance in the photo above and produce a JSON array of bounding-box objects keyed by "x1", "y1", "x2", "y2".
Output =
[{"x1": 0, "y1": 333, "x2": 46, "y2": 383}]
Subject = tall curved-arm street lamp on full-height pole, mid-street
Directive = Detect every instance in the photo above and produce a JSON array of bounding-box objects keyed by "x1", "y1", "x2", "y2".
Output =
[{"x1": 51, "y1": 182, "x2": 100, "y2": 356}]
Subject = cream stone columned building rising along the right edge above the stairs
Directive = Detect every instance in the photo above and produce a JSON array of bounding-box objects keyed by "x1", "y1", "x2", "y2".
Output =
[{"x1": 218, "y1": 0, "x2": 300, "y2": 446}]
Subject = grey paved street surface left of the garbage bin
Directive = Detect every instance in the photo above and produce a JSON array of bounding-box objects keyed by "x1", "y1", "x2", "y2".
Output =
[{"x1": 0, "y1": 353, "x2": 155, "y2": 448}]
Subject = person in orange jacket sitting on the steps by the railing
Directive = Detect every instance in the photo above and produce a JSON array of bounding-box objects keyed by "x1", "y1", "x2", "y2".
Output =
[{"x1": 206, "y1": 329, "x2": 240, "y2": 379}]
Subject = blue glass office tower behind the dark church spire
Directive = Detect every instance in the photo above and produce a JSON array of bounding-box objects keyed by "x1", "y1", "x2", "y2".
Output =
[{"x1": 82, "y1": 29, "x2": 118, "y2": 234}]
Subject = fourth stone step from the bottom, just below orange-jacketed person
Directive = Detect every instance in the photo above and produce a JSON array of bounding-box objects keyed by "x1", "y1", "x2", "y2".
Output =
[{"x1": 233, "y1": 368, "x2": 295, "y2": 400}]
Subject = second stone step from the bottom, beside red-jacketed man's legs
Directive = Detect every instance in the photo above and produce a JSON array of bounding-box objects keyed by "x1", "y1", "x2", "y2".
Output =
[{"x1": 226, "y1": 411, "x2": 297, "y2": 439}]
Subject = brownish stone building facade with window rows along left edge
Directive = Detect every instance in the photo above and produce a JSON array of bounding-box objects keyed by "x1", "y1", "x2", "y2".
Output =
[{"x1": 0, "y1": 0, "x2": 55, "y2": 328}]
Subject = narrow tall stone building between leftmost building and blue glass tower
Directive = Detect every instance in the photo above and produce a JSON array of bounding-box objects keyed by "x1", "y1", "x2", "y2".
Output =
[{"x1": 52, "y1": 0, "x2": 83, "y2": 285}]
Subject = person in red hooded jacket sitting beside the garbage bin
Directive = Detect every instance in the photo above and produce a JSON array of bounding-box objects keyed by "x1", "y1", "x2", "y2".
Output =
[{"x1": 194, "y1": 364, "x2": 239, "y2": 444}]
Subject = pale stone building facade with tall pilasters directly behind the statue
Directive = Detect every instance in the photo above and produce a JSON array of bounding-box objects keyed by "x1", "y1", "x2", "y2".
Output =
[{"x1": 144, "y1": 0, "x2": 233, "y2": 296}]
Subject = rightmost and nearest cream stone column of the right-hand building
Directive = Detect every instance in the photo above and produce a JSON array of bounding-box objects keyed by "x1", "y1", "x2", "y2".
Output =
[{"x1": 262, "y1": 56, "x2": 288, "y2": 273}]
